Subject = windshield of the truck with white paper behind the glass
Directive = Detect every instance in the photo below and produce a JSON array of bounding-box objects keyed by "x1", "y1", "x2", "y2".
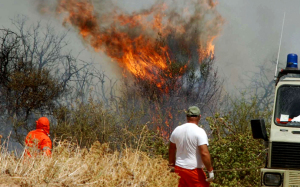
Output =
[{"x1": 275, "y1": 85, "x2": 300, "y2": 127}]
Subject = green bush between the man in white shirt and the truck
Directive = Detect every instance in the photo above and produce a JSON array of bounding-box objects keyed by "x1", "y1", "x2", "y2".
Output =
[{"x1": 207, "y1": 97, "x2": 271, "y2": 187}]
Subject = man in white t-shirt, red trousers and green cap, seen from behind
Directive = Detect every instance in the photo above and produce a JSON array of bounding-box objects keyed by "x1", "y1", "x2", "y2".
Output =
[{"x1": 169, "y1": 106, "x2": 214, "y2": 187}]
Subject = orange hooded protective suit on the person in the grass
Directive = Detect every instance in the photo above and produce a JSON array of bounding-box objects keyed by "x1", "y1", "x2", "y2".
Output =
[{"x1": 25, "y1": 117, "x2": 52, "y2": 157}]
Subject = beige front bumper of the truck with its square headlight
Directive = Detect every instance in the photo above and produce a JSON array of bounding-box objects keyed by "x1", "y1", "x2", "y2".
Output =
[{"x1": 260, "y1": 168, "x2": 300, "y2": 187}]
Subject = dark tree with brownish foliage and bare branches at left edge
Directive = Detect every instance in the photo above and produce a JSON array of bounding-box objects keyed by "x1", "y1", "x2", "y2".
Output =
[{"x1": 0, "y1": 29, "x2": 64, "y2": 142}]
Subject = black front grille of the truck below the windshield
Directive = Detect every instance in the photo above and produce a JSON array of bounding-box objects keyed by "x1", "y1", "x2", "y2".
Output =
[{"x1": 271, "y1": 142, "x2": 300, "y2": 169}]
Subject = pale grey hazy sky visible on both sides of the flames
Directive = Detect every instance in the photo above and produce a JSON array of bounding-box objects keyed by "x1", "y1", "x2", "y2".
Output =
[{"x1": 0, "y1": 0, "x2": 300, "y2": 92}]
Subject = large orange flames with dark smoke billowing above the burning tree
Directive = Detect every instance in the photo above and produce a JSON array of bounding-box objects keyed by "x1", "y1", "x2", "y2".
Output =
[{"x1": 56, "y1": 0, "x2": 222, "y2": 92}]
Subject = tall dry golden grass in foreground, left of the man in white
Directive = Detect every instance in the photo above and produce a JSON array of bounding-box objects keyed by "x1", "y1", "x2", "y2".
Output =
[{"x1": 0, "y1": 141, "x2": 178, "y2": 187}]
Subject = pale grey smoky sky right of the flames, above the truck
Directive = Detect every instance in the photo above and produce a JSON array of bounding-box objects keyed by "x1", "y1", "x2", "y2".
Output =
[{"x1": 215, "y1": 0, "x2": 300, "y2": 90}]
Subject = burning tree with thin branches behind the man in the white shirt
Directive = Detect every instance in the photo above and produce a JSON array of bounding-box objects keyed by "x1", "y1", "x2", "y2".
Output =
[{"x1": 119, "y1": 35, "x2": 222, "y2": 139}]
